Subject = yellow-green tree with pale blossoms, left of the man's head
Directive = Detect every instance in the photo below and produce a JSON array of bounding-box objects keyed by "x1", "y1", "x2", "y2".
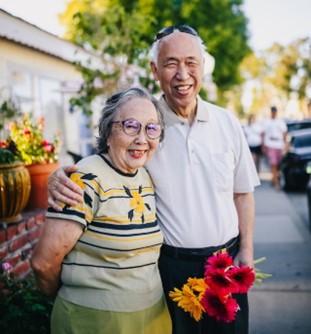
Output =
[{"x1": 61, "y1": 0, "x2": 157, "y2": 115}]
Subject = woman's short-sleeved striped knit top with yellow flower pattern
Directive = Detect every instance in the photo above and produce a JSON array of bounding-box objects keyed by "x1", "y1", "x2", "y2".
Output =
[{"x1": 47, "y1": 155, "x2": 163, "y2": 312}]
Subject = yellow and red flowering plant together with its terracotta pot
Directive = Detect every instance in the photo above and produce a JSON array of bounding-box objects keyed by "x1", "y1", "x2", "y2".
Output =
[{"x1": 9, "y1": 114, "x2": 61, "y2": 210}]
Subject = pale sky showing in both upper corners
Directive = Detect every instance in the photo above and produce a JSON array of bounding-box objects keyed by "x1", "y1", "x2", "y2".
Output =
[{"x1": 0, "y1": 0, "x2": 311, "y2": 50}]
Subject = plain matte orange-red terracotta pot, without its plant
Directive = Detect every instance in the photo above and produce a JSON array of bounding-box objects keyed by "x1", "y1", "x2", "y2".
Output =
[{"x1": 26, "y1": 162, "x2": 59, "y2": 210}]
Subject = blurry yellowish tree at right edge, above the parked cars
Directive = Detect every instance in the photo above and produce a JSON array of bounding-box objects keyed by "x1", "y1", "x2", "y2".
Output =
[{"x1": 241, "y1": 38, "x2": 311, "y2": 116}]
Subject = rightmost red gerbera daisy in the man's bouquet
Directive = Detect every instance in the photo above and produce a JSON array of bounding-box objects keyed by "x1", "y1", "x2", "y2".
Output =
[{"x1": 228, "y1": 266, "x2": 255, "y2": 293}]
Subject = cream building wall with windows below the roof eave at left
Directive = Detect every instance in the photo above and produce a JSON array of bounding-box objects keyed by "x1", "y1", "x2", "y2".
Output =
[{"x1": 0, "y1": 38, "x2": 94, "y2": 165}]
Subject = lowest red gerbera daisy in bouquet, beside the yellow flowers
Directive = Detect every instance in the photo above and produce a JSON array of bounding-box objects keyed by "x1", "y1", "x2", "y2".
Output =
[{"x1": 201, "y1": 289, "x2": 239, "y2": 322}]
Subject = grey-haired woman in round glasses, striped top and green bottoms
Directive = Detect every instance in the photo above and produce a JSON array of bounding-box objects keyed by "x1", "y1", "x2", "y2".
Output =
[{"x1": 31, "y1": 88, "x2": 171, "y2": 334}]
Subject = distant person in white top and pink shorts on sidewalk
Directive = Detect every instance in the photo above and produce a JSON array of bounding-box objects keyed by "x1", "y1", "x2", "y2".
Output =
[{"x1": 263, "y1": 106, "x2": 287, "y2": 190}]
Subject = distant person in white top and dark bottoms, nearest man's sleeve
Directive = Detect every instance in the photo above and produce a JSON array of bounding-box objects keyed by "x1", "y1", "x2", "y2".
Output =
[{"x1": 243, "y1": 114, "x2": 263, "y2": 172}]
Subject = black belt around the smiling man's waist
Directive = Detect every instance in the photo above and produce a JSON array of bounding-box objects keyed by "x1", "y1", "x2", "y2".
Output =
[{"x1": 161, "y1": 237, "x2": 239, "y2": 261}]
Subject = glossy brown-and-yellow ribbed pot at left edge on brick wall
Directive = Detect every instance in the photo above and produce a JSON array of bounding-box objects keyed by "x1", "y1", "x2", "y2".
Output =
[{"x1": 0, "y1": 162, "x2": 30, "y2": 223}]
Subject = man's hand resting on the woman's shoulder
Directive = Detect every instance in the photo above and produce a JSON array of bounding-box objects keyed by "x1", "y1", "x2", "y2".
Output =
[{"x1": 48, "y1": 165, "x2": 83, "y2": 212}]
